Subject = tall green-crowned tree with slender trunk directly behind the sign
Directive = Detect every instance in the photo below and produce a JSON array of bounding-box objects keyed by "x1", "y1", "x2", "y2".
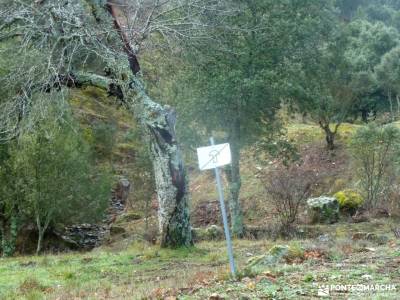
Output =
[{"x1": 172, "y1": 1, "x2": 331, "y2": 236}]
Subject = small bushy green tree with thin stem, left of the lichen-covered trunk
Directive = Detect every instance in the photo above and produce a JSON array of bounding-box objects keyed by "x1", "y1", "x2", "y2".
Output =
[{"x1": 15, "y1": 99, "x2": 111, "y2": 253}]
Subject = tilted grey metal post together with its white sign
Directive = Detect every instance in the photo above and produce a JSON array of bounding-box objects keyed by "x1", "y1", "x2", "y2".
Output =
[{"x1": 197, "y1": 137, "x2": 236, "y2": 277}]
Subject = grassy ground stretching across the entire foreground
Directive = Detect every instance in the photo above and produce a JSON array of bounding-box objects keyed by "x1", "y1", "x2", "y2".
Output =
[{"x1": 0, "y1": 220, "x2": 400, "y2": 299}]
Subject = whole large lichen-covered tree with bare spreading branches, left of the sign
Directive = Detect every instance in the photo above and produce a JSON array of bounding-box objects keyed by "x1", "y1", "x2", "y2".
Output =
[{"x1": 0, "y1": 0, "x2": 219, "y2": 247}]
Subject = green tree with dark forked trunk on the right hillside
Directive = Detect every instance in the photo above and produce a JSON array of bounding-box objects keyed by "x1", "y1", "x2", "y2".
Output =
[{"x1": 289, "y1": 24, "x2": 354, "y2": 150}]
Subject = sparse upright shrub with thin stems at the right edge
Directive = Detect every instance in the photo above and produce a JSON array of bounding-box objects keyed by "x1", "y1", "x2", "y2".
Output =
[{"x1": 350, "y1": 124, "x2": 400, "y2": 207}]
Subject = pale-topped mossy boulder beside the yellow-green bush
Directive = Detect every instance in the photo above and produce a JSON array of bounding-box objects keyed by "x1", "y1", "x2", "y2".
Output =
[{"x1": 307, "y1": 196, "x2": 339, "y2": 224}]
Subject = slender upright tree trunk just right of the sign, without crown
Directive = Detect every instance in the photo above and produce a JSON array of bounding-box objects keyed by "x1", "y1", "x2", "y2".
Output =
[{"x1": 227, "y1": 120, "x2": 243, "y2": 237}]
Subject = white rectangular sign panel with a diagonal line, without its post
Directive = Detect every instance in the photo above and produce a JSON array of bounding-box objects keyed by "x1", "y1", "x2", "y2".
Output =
[{"x1": 197, "y1": 143, "x2": 231, "y2": 170}]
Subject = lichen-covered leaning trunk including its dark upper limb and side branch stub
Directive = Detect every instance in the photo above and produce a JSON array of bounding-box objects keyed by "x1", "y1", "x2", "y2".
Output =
[{"x1": 78, "y1": 1, "x2": 193, "y2": 247}]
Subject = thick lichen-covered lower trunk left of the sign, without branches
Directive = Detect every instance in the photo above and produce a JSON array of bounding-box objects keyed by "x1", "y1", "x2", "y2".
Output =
[{"x1": 131, "y1": 84, "x2": 193, "y2": 247}]
